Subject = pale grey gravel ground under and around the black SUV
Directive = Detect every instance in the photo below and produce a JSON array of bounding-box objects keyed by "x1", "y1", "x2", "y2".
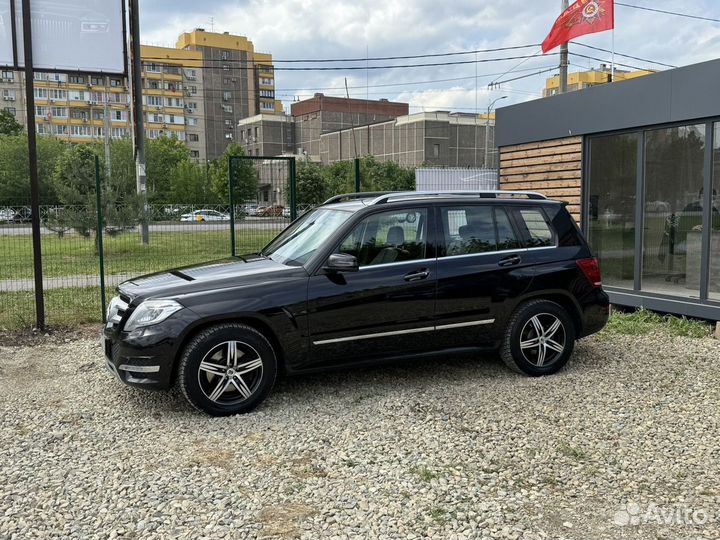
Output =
[{"x1": 0, "y1": 334, "x2": 720, "y2": 540}]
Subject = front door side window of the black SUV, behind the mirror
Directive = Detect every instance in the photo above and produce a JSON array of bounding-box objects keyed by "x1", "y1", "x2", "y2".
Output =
[{"x1": 337, "y1": 209, "x2": 427, "y2": 266}]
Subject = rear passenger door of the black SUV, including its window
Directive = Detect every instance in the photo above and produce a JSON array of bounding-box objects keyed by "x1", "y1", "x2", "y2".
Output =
[{"x1": 428, "y1": 203, "x2": 532, "y2": 347}]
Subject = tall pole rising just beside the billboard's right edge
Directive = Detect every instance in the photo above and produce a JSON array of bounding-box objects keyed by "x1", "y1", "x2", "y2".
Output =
[{"x1": 129, "y1": 0, "x2": 150, "y2": 244}]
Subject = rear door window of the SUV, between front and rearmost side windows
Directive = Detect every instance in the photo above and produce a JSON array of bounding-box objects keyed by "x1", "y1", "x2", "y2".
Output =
[{"x1": 441, "y1": 205, "x2": 520, "y2": 257}]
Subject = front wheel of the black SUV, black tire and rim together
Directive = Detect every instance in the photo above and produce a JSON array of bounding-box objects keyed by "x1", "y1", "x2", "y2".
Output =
[{"x1": 178, "y1": 323, "x2": 277, "y2": 416}]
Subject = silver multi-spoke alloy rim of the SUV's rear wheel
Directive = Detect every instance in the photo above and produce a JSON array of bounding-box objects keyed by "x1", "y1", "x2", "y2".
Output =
[{"x1": 520, "y1": 313, "x2": 567, "y2": 367}]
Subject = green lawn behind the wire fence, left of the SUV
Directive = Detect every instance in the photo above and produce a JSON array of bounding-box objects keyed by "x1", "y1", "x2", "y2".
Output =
[{"x1": 0, "y1": 228, "x2": 279, "y2": 280}]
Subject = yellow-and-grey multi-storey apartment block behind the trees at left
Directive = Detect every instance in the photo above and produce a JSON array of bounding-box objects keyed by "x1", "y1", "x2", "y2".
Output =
[{"x1": 0, "y1": 29, "x2": 282, "y2": 161}]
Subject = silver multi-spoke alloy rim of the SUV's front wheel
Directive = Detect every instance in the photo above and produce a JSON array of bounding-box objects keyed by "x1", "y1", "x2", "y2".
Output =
[{"x1": 198, "y1": 341, "x2": 263, "y2": 405}]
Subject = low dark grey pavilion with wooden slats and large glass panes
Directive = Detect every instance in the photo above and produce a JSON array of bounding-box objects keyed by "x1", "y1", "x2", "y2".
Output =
[{"x1": 497, "y1": 60, "x2": 720, "y2": 320}]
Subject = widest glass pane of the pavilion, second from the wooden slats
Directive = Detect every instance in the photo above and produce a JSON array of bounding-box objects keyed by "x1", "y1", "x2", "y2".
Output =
[{"x1": 642, "y1": 124, "x2": 705, "y2": 298}]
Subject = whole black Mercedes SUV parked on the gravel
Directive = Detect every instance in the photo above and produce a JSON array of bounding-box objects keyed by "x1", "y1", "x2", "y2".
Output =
[{"x1": 104, "y1": 192, "x2": 609, "y2": 416}]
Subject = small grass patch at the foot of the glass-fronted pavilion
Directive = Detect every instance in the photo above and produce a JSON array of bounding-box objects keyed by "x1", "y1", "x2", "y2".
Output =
[{"x1": 604, "y1": 308, "x2": 712, "y2": 338}]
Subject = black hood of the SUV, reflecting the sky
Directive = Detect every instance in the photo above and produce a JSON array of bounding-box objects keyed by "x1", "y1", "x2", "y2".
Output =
[{"x1": 118, "y1": 255, "x2": 305, "y2": 301}]
